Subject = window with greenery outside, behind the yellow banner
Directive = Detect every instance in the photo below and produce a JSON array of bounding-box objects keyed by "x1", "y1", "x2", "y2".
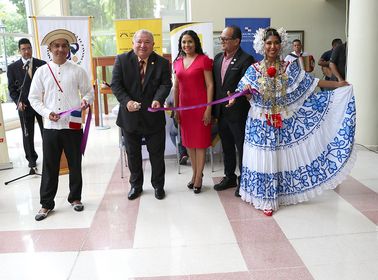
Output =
[{"x1": 69, "y1": 0, "x2": 187, "y2": 56}]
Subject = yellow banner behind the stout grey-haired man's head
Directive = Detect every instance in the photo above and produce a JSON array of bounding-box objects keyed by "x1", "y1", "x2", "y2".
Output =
[{"x1": 114, "y1": 18, "x2": 163, "y2": 55}]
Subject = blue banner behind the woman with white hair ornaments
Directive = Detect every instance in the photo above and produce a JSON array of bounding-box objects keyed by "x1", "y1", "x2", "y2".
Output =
[{"x1": 225, "y1": 18, "x2": 270, "y2": 61}]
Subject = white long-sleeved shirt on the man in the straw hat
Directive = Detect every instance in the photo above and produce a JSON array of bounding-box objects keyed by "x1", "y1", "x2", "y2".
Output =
[{"x1": 29, "y1": 60, "x2": 93, "y2": 129}]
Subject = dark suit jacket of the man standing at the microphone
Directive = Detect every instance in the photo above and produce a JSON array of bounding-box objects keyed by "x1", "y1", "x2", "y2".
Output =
[{"x1": 7, "y1": 57, "x2": 46, "y2": 108}]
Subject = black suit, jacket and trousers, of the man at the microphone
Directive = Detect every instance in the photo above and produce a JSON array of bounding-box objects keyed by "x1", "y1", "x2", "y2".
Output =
[{"x1": 7, "y1": 58, "x2": 46, "y2": 167}]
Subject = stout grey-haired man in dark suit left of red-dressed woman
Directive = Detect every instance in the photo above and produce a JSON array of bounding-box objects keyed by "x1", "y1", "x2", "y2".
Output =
[{"x1": 111, "y1": 30, "x2": 172, "y2": 200}]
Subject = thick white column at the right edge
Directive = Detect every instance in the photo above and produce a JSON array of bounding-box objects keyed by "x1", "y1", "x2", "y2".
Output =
[{"x1": 347, "y1": 0, "x2": 378, "y2": 148}]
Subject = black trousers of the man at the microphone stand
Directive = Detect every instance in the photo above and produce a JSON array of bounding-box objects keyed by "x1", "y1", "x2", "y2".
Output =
[{"x1": 18, "y1": 108, "x2": 43, "y2": 163}]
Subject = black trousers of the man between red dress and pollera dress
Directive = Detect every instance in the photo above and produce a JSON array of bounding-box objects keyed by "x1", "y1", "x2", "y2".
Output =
[{"x1": 218, "y1": 117, "x2": 246, "y2": 178}]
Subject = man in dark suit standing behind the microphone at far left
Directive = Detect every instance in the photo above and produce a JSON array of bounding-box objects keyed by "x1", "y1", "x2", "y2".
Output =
[{"x1": 7, "y1": 38, "x2": 46, "y2": 168}]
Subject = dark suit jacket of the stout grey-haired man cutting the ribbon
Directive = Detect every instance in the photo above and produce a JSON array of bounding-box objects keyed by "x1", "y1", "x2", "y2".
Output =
[{"x1": 111, "y1": 51, "x2": 172, "y2": 134}]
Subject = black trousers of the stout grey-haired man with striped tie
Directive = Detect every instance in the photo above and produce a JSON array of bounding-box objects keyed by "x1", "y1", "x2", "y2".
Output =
[{"x1": 124, "y1": 129, "x2": 165, "y2": 189}]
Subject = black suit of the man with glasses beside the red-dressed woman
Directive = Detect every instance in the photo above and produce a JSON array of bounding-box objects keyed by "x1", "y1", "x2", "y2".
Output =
[{"x1": 212, "y1": 48, "x2": 255, "y2": 178}]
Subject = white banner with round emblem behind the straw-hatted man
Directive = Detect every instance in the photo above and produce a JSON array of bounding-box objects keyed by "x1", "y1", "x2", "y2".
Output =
[{"x1": 34, "y1": 17, "x2": 92, "y2": 77}]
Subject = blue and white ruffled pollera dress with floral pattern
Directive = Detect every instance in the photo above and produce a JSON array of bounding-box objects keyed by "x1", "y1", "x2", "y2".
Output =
[{"x1": 238, "y1": 60, "x2": 356, "y2": 210}]
